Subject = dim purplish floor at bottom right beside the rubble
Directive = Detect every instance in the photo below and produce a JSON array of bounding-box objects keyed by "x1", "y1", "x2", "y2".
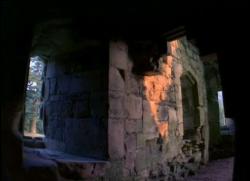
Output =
[{"x1": 186, "y1": 157, "x2": 234, "y2": 181}]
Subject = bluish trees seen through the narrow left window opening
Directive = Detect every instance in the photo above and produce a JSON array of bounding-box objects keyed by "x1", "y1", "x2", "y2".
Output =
[{"x1": 24, "y1": 57, "x2": 44, "y2": 134}]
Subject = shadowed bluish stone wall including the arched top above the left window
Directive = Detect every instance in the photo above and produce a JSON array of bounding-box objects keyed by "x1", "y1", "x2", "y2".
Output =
[{"x1": 31, "y1": 21, "x2": 108, "y2": 159}]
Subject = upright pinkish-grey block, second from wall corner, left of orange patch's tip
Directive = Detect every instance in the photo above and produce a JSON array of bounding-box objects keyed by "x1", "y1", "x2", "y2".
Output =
[{"x1": 127, "y1": 95, "x2": 142, "y2": 119}]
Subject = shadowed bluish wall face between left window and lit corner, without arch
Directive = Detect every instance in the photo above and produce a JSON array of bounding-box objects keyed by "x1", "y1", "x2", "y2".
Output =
[{"x1": 43, "y1": 42, "x2": 108, "y2": 158}]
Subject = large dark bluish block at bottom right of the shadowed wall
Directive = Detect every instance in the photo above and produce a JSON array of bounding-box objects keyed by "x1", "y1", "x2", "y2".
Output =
[{"x1": 63, "y1": 118, "x2": 106, "y2": 158}]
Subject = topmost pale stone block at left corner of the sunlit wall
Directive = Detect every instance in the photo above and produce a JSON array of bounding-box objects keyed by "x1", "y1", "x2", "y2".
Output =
[{"x1": 109, "y1": 42, "x2": 128, "y2": 70}]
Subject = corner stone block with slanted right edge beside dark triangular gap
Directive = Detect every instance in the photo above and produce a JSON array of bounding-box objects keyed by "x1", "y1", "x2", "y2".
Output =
[{"x1": 109, "y1": 67, "x2": 125, "y2": 91}]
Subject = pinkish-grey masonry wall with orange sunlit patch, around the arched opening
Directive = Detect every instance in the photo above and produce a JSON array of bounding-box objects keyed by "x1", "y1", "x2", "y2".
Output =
[{"x1": 107, "y1": 37, "x2": 208, "y2": 180}]
